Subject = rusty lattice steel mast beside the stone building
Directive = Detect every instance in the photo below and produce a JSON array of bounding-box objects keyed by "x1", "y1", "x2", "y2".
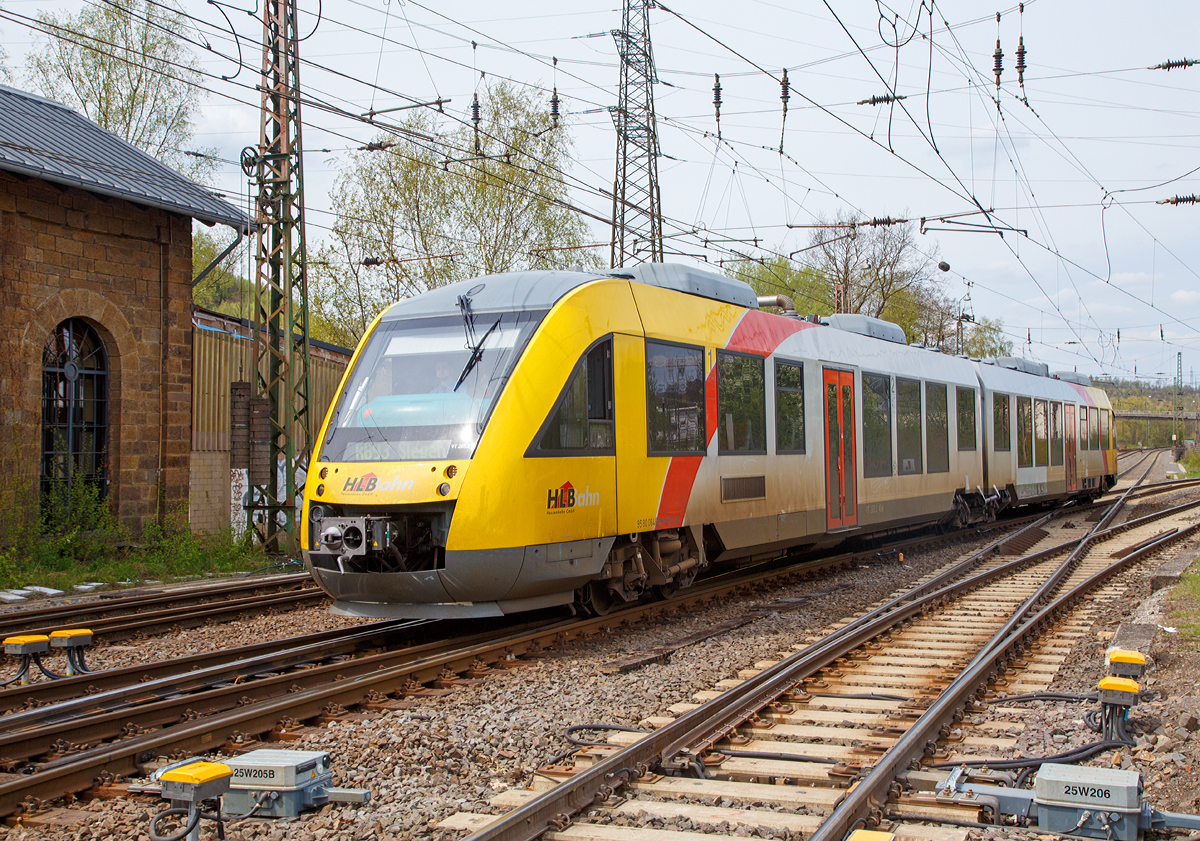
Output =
[{"x1": 244, "y1": 0, "x2": 313, "y2": 552}]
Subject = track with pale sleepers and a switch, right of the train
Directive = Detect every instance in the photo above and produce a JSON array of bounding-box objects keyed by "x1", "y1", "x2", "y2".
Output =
[{"x1": 440, "y1": 468, "x2": 1200, "y2": 841}]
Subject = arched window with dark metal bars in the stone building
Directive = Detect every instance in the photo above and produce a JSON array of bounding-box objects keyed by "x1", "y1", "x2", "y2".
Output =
[{"x1": 42, "y1": 318, "x2": 108, "y2": 499}]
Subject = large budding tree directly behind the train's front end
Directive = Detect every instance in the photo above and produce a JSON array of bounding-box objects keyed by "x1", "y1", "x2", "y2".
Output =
[{"x1": 310, "y1": 83, "x2": 600, "y2": 347}]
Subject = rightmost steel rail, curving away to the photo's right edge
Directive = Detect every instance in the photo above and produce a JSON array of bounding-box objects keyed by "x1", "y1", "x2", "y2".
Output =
[{"x1": 809, "y1": 523, "x2": 1200, "y2": 841}]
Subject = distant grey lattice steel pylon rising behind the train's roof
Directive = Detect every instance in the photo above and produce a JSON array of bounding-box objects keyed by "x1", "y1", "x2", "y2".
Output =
[{"x1": 610, "y1": 0, "x2": 662, "y2": 269}]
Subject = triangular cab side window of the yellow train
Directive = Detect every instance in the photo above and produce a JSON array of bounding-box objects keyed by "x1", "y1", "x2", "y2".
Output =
[{"x1": 532, "y1": 338, "x2": 617, "y2": 456}]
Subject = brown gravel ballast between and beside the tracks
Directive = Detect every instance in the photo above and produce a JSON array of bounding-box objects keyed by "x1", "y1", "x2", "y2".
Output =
[{"x1": 9, "y1": 476, "x2": 1200, "y2": 841}]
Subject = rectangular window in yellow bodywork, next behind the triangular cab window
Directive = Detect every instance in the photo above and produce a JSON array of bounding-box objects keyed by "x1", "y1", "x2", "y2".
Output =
[{"x1": 646, "y1": 340, "x2": 708, "y2": 456}]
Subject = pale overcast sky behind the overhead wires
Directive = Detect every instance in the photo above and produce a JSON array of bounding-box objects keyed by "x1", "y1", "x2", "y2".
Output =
[{"x1": 0, "y1": 0, "x2": 1200, "y2": 382}]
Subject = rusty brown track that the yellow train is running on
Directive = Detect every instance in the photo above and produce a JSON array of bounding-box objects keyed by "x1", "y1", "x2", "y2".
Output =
[{"x1": 0, "y1": 508, "x2": 1049, "y2": 815}]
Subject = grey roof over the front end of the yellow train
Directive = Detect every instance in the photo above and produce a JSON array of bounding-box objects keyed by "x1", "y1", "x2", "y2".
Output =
[{"x1": 383, "y1": 263, "x2": 758, "y2": 320}]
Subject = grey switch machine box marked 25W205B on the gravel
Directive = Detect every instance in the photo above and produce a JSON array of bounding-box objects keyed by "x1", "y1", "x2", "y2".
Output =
[{"x1": 222, "y1": 749, "x2": 371, "y2": 818}]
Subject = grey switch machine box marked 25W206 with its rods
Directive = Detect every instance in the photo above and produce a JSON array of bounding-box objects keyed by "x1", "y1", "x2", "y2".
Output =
[{"x1": 937, "y1": 762, "x2": 1200, "y2": 841}]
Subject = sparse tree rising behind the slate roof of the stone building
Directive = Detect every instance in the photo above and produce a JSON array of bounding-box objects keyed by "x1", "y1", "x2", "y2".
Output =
[{"x1": 25, "y1": 0, "x2": 212, "y2": 178}]
